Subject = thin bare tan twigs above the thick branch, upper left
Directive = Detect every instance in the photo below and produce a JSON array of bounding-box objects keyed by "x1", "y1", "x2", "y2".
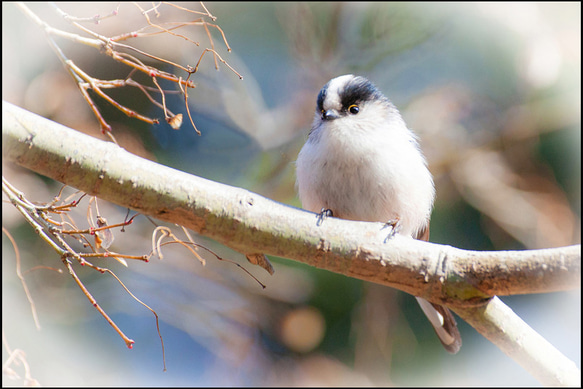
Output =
[{"x1": 19, "y1": 2, "x2": 243, "y2": 143}]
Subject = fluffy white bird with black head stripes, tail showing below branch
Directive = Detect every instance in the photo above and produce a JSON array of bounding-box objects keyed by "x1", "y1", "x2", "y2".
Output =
[{"x1": 296, "y1": 74, "x2": 461, "y2": 354}]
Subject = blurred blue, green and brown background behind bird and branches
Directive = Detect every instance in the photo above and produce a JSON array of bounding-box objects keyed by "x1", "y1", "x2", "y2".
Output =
[{"x1": 2, "y1": 2, "x2": 581, "y2": 386}]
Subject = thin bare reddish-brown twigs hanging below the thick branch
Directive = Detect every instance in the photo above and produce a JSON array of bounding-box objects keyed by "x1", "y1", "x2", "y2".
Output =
[{"x1": 2, "y1": 177, "x2": 265, "y2": 370}]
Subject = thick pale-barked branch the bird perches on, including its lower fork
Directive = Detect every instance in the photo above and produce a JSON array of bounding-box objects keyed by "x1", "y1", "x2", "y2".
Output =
[{"x1": 2, "y1": 102, "x2": 581, "y2": 385}]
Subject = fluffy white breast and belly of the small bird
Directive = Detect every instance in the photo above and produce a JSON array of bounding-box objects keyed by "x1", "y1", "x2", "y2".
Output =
[{"x1": 296, "y1": 109, "x2": 434, "y2": 236}]
